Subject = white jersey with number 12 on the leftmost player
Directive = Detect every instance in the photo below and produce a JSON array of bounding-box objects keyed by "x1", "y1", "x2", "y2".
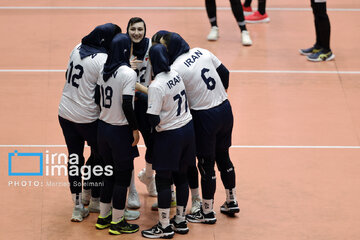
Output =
[{"x1": 59, "y1": 44, "x2": 107, "y2": 123}]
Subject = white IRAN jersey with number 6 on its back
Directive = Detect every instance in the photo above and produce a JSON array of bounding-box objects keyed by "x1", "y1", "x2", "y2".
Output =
[{"x1": 171, "y1": 48, "x2": 227, "y2": 110}]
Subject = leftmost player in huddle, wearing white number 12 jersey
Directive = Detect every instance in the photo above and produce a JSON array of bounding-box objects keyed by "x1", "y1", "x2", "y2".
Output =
[{"x1": 59, "y1": 23, "x2": 121, "y2": 222}]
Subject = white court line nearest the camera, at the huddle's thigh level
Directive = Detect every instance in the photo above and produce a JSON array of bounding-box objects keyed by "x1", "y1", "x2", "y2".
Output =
[{"x1": 0, "y1": 145, "x2": 360, "y2": 149}]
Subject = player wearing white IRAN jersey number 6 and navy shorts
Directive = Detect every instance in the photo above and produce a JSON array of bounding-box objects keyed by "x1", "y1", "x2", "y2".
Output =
[{"x1": 161, "y1": 33, "x2": 240, "y2": 224}]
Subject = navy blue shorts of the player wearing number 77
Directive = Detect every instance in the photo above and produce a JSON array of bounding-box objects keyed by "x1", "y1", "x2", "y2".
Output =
[{"x1": 152, "y1": 121, "x2": 196, "y2": 172}]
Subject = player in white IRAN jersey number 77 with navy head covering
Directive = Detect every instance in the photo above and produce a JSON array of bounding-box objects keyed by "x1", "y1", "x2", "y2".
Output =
[{"x1": 142, "y1": 44, "x2": 195, "y2": 238}]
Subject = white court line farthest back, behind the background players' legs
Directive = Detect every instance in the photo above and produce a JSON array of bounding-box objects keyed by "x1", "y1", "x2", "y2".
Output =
[{"x1": 0, "y1": 6, "x2": 360, "y2": 12}]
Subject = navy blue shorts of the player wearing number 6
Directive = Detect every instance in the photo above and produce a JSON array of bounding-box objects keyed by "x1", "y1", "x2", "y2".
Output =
[{"x1": 191, "y1": 100, "x2": 234, "y2": 158}]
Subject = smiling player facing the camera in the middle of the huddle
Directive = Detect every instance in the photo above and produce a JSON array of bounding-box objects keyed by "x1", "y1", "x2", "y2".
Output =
[{"x1": 126, "y1": 17, "x2": 157, "y2": 209}]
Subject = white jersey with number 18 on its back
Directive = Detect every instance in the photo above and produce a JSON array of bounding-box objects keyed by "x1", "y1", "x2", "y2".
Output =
[{"x1": 98, "y1": 65, "x2": 136, "y2": 125}]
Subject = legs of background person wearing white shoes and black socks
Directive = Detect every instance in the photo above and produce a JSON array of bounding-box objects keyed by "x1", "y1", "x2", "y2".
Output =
[{"x1": 205, "y1": 0, "x2": 252, "y2": 46}]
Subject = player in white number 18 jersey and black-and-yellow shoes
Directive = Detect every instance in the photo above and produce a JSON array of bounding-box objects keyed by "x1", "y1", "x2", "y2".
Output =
[{"x1": 95, "y1": 34, "x2": 139, "y2": 235}]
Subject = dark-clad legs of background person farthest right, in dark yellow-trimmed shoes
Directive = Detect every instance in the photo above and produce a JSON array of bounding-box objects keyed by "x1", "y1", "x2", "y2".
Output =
[{"x1": 300, "y1": 0, "x2": 335, "y2": 62}]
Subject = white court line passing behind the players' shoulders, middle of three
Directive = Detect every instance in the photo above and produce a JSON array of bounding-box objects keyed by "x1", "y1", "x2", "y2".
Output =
[{"x1": 0, "y1": 69, "x2": 360, "y2": 74}]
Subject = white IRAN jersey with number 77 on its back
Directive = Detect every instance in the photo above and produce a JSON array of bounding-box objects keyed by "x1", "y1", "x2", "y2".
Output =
[{"x1": 147, "y1": 70, "x2": 192, "y2": 132}]
